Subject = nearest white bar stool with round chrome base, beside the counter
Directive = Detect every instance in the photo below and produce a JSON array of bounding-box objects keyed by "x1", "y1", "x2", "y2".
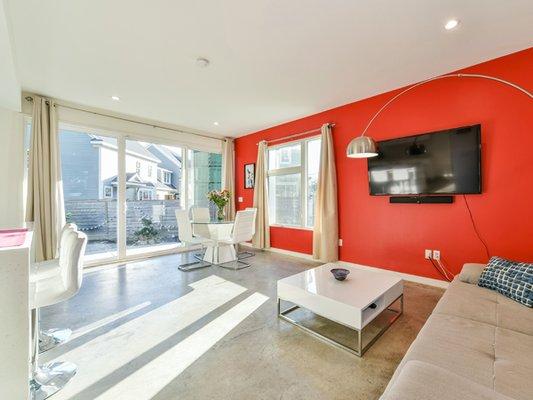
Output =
[{"x1": 30, "y1": 229, "x2": 87, "y2": 399}]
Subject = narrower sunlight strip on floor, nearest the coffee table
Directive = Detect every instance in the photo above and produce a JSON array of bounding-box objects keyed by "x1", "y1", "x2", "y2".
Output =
[{"x1": 97, "y1": 293, "x2": 268, "y2": 400}]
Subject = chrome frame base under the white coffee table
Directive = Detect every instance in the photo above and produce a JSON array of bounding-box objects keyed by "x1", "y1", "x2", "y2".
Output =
[{"x1": 278, "y1": 294, "x2": 403, "y2": 357}]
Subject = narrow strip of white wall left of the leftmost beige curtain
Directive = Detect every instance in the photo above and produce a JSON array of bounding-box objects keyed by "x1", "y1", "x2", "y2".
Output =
[{"x1": 0, "y1": 107, "x2": 25, "y2": 228}]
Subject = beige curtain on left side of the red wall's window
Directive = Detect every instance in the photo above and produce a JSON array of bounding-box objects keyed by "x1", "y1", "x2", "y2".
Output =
[{"x1": 252, "y1": 140, "x2": 270, "y2": 249}]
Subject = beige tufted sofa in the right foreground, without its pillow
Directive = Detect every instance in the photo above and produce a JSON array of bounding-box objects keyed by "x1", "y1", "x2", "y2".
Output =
[{"x1": 381, "y1": 264, "x2": 533, "y2": 400}]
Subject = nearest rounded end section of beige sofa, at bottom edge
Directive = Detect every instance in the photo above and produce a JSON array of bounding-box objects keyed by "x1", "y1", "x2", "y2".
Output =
[{"x1": 380, "y1": 360, "x2": 513, "y2": 400}]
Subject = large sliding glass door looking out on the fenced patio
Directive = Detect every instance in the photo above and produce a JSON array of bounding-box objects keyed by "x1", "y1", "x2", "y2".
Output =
[{"x1": 45, "y1": 123, "x2": 222, "y2": 264}]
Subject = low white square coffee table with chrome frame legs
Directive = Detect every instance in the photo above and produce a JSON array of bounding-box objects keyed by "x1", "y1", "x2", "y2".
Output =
[{"x1": 278, "y1": 263, "x2": 403, "y2": 357}]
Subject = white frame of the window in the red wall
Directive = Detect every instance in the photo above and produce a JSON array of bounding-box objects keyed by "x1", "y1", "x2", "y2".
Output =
[{"x1": 266, "y1": 134, "x2": 322, "y2": 231}]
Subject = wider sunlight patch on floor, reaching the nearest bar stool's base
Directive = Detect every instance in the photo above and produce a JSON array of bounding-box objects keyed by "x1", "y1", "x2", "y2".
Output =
[{"x1": 46, "y1": 275, "x2": 246, "y2": 400}]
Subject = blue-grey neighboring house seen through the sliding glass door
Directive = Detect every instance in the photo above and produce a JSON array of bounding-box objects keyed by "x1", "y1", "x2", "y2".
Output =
[{"x1": 60, "y1": 130, "x2": 179, "y2": 200}]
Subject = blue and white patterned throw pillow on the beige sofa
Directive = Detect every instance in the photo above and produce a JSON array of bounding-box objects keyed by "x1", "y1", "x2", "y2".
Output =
[{"x1": 478, "y1": 257, "x2": 533, "y2": 307}]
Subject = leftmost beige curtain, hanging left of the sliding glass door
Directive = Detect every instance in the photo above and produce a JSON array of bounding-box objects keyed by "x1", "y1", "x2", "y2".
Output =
[{"x1": 26, "y1": 96, "x2": 65, "y2": 261}]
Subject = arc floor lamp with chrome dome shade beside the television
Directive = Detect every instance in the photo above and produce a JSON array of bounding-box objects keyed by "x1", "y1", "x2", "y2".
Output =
[{"x1": 346, "y1": 74, "x2": 533, "y2": 158}]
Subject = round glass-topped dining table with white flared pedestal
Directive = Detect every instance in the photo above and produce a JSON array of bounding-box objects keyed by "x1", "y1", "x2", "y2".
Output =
[{"x1": 191, "y1": 220, "x2": 237, "y2": 264}]
